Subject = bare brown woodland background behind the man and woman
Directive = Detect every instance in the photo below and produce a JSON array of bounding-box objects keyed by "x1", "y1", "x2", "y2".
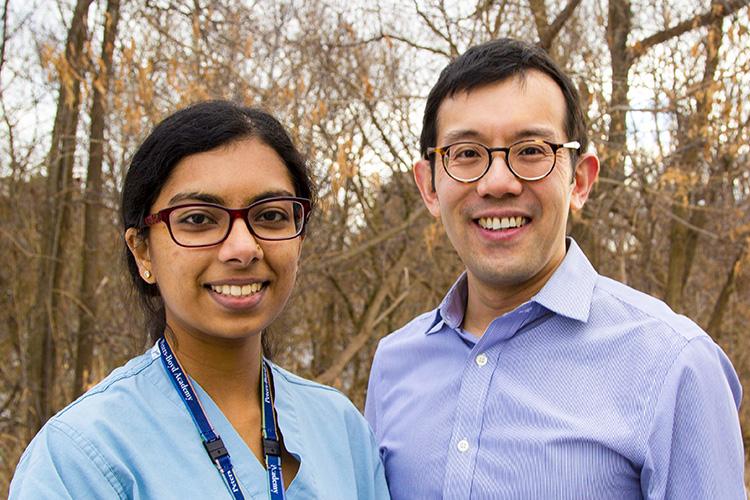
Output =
[{"x1": 0, "y1": 0, "x2": 750, "y2": 491}]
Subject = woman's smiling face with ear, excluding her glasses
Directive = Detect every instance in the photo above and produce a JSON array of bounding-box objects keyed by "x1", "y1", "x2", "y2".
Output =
[{"x1": 126, "y1": 138, "x2": 302, "y2": 346}]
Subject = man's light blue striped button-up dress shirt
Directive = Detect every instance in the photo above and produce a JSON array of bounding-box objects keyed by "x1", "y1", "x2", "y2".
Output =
[{"x1": 365, "y1": 240, "x2": 746, "y2": 500}]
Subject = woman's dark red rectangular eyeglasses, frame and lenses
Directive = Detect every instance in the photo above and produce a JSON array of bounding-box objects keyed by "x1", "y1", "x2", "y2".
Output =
[{"x1": 144, "y1": 196, "x2": 310, "y2": 248}]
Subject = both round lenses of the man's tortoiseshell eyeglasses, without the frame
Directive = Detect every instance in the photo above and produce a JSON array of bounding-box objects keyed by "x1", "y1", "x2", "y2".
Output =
[{"x1": 443, "y1": 141, "x2": 555, "y2": 180}]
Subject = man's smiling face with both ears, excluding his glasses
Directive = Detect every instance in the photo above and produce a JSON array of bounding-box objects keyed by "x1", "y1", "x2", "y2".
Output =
[{"x1": 414, "y1": 71, "x2": 598, "y2": 295}]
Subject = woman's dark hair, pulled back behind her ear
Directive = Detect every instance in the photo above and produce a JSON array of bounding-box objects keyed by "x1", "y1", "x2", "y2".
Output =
[{"x1": 122, "y1": 101, "x2": 315, "y2": 350}]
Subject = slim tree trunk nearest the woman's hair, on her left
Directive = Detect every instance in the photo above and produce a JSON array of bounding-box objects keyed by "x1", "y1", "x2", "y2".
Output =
[{"x1": 73, "y1": 0, "x2": 120, "y2": 396}]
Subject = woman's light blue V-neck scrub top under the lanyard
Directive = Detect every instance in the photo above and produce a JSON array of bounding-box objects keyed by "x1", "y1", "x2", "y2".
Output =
[{"x1": 10, "y1": 346, "x2": 390, "y2": 500}]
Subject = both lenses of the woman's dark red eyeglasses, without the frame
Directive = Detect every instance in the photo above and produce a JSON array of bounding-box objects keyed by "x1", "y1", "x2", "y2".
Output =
[{"x1": 169, "y1": 200, "x2": 305, "y2": 246}]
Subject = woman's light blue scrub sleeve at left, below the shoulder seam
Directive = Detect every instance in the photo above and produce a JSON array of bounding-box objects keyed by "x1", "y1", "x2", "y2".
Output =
[{"x1": 9, "y1": 421, "x2": 127, "y2": 500}]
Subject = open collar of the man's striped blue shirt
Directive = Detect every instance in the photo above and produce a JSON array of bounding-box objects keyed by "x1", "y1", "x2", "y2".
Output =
[{"x1": 425, "y1": 238, "x2": 598, "y2": 335}]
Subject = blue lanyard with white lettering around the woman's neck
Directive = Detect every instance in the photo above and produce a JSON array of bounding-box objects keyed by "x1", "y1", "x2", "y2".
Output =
[{"x1": 157, "y1": 337, "x2": 285, "y2": 500}]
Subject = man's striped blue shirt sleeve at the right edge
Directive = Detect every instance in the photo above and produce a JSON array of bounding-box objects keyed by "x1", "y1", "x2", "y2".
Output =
[{"x1": 641, "y1": 335, "x2": 747, "y2": 499}]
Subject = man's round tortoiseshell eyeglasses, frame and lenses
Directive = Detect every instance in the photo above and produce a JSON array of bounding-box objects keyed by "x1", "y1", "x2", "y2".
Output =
[{"x1": 426, "y1": 139, "x2": 581, "y2": 183}]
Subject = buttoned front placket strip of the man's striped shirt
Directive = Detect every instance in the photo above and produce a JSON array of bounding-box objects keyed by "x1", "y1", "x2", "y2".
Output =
[{"x1": 443, "y1": 308, "x2": 528, "y2": 500}]
